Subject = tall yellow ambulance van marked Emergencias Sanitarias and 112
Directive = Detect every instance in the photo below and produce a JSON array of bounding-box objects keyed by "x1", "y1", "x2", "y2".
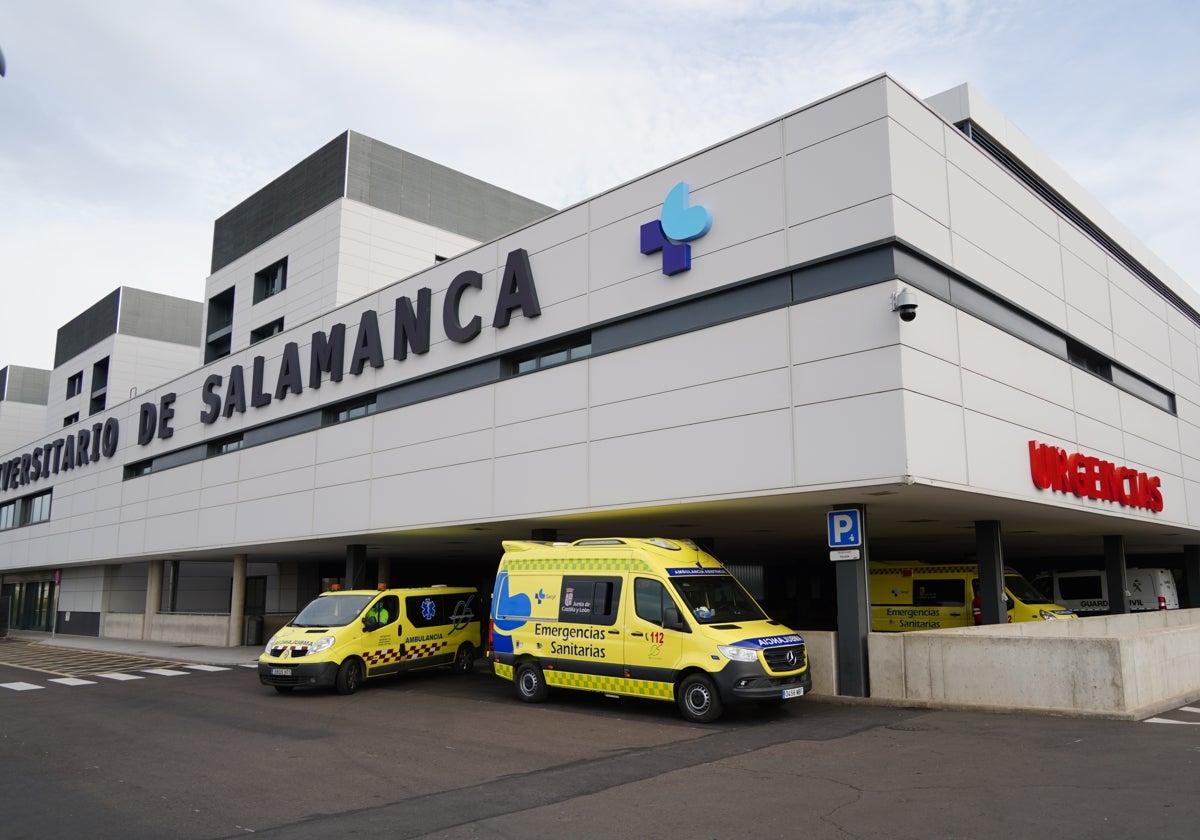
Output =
[{"x1": 488, "y1": 538, "x2": 812, "y2": 722}]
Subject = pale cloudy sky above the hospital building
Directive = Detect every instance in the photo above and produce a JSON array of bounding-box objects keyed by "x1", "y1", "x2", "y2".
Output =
[{"x1": 0, "y1": 0, "x2": 1200, "y2": 368}]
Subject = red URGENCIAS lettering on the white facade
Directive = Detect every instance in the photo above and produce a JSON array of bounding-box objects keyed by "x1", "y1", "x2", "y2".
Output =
[{"x1": 1030, "y1": 440, "x2": 1163, "y2": 514}]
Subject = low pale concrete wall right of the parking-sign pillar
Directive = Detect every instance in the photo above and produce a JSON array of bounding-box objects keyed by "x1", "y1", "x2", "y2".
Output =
[{"x1": 868, "y1": 610, "x2": 1200, "y2": 719}]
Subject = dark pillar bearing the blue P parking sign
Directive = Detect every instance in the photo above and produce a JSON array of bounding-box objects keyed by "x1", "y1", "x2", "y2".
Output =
[{"x1": 827, "y1": 504, "x2": 870, "y2": 697}]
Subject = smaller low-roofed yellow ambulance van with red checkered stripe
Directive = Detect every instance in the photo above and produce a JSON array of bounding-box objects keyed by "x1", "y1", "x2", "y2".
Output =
[{"x1": 258, "y1": 587, "x2": 482, "y2": 694}]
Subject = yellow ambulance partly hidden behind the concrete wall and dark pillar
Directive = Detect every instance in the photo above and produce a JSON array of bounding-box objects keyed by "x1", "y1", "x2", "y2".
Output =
[{"x1": 869, "y1": 560, "x2": 1076, "y2": 632}]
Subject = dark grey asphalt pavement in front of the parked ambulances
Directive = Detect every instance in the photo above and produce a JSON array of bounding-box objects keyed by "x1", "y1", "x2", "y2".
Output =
[{"x1": 0, "y1": 648, "x2": 1200, "y2": 840}]
